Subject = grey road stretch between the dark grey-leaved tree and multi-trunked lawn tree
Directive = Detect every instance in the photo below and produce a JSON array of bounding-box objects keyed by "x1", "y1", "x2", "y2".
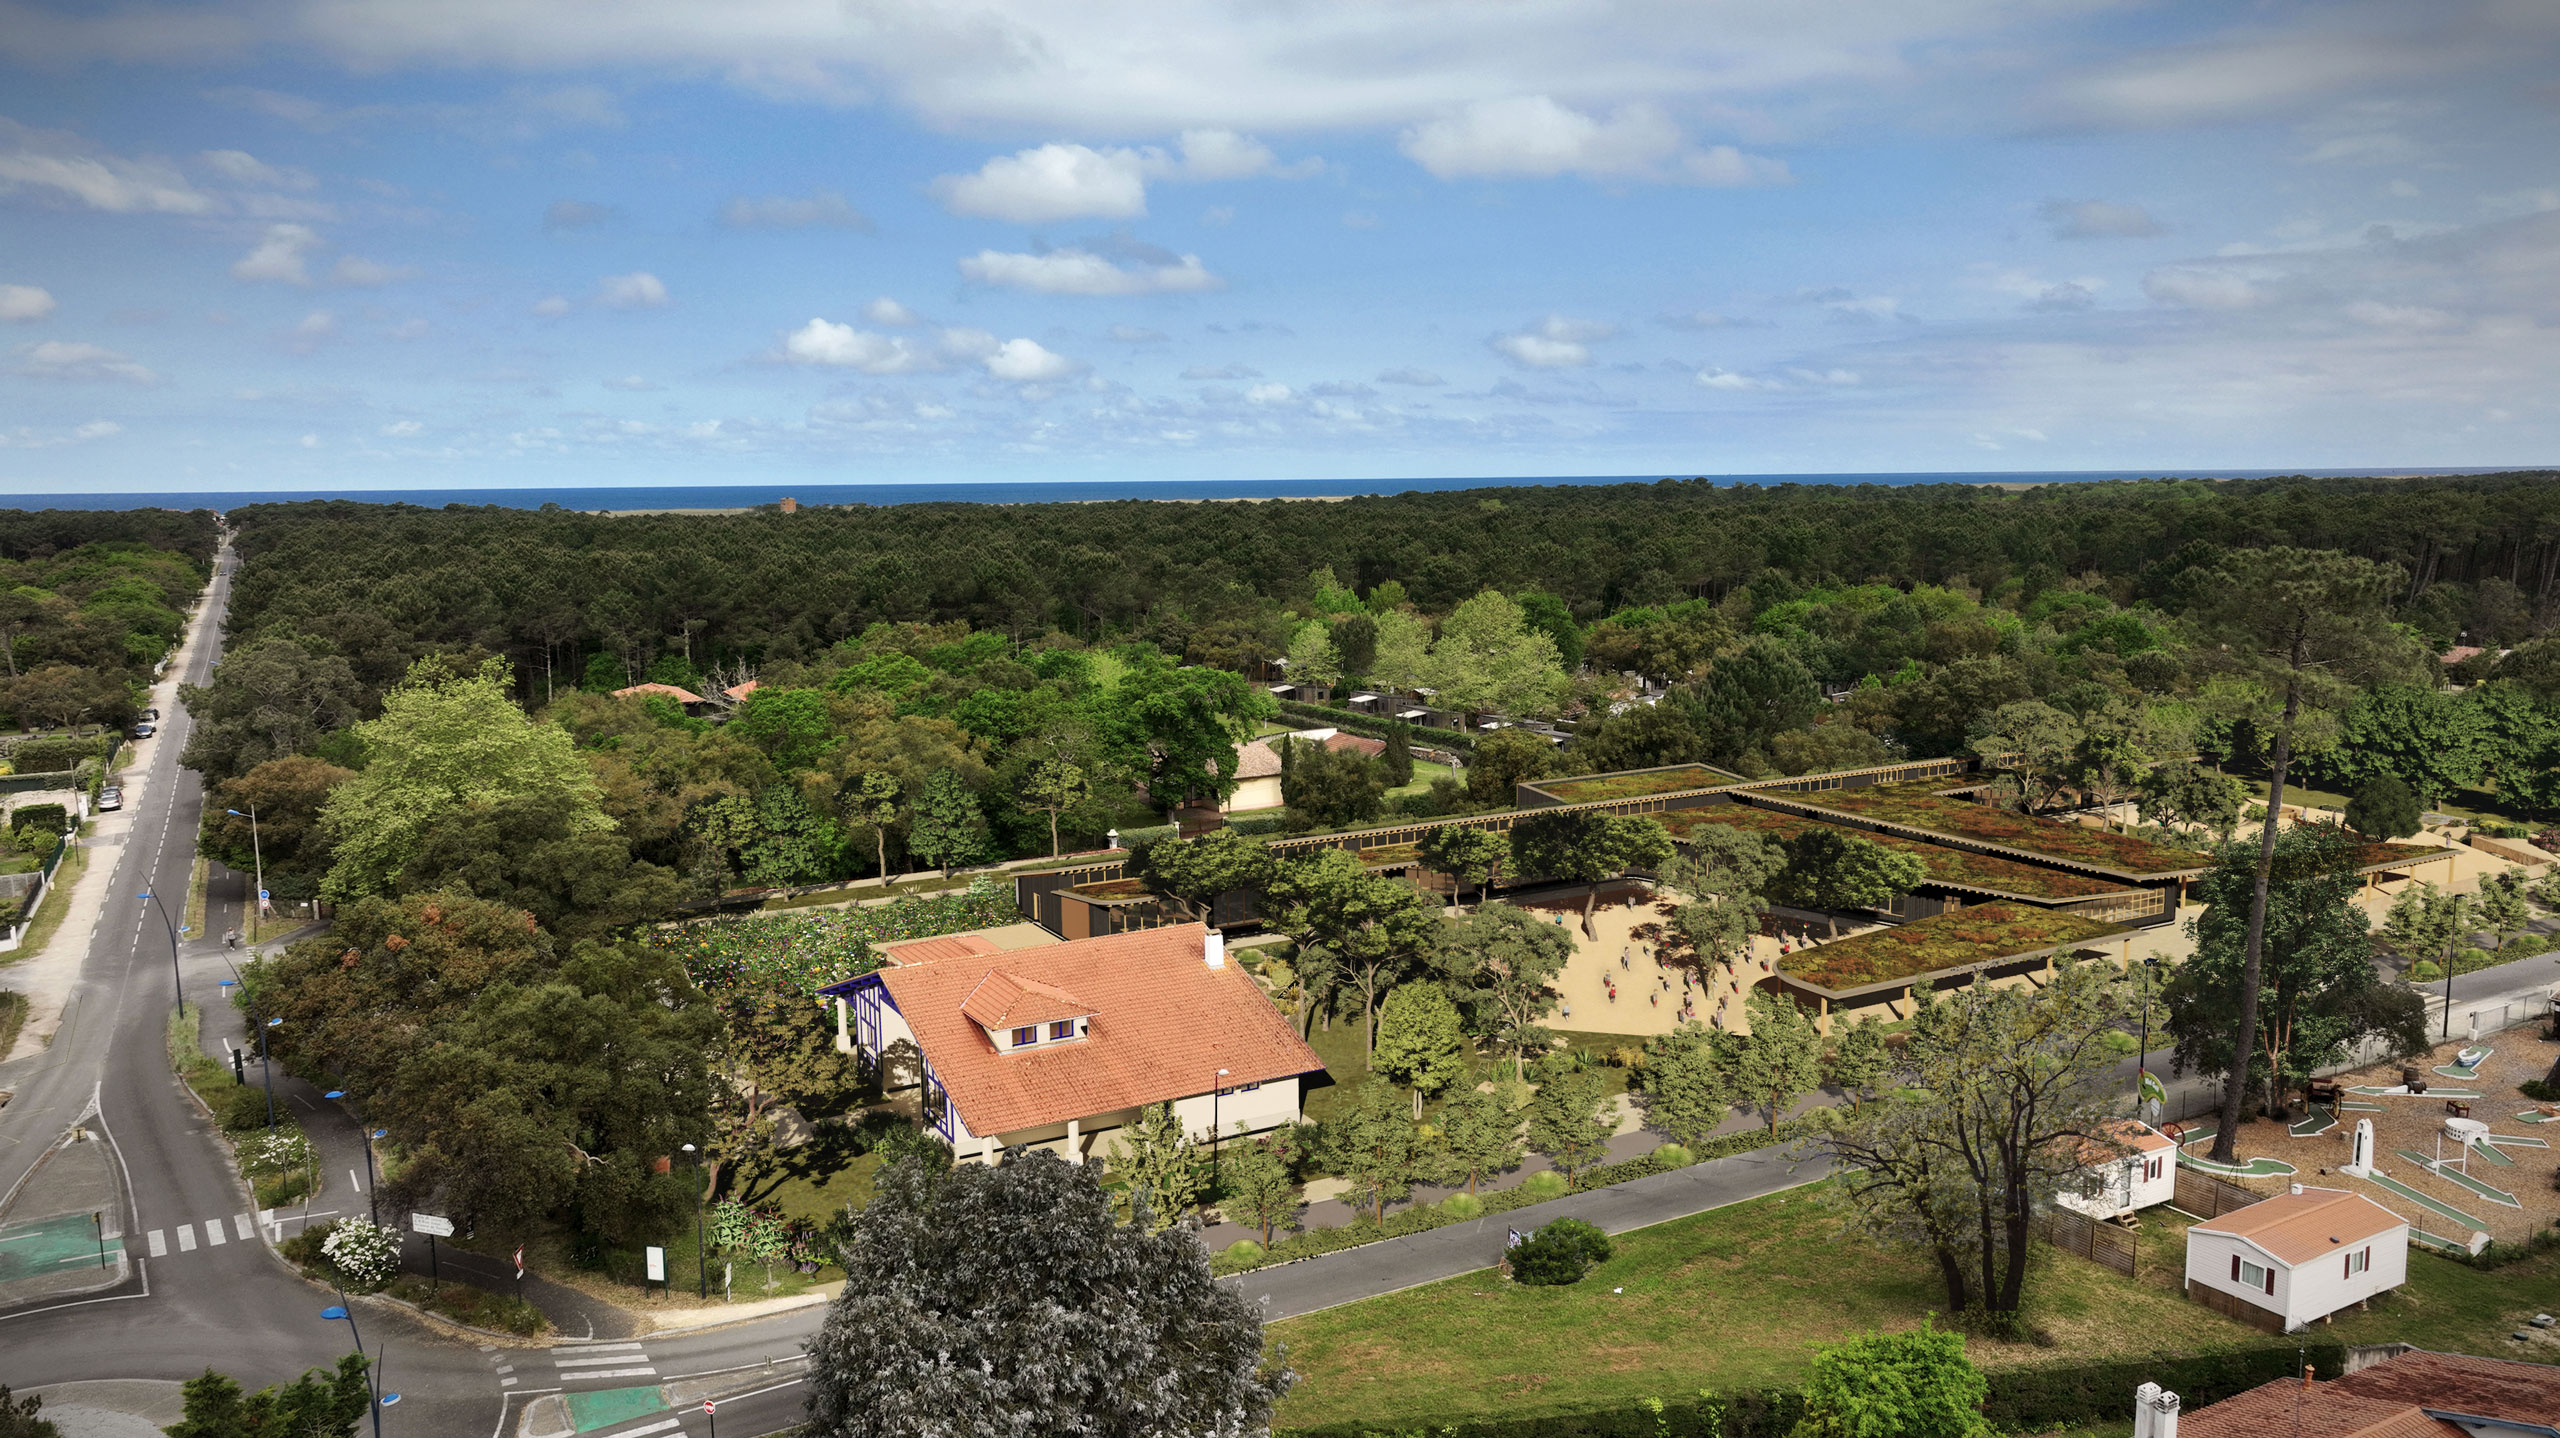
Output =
[{"x1": 1219, "y1": 1144, "x2": 1830, "y2": 1318}]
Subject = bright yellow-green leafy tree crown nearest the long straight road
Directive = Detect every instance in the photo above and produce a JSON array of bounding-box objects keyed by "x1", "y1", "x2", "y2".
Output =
[{"x1": 320, "y1": 660, "x2": 612, "y2": 901}]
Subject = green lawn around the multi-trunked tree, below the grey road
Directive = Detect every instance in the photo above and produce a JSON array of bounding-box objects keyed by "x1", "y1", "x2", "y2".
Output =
[{"x1": 1270, "y1": 1187, "x2": 2266, "y2": 1430}]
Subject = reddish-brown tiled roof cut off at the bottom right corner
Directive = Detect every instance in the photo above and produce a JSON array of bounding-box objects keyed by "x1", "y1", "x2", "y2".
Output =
[{"x1": 2170, "y1": 1348, "x2": 2560, "y2": 1438}]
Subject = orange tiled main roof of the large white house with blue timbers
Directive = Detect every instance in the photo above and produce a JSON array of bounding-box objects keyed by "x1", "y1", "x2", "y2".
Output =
[{"x1": 878, "y1": 924, "x2": 1324, "y2": 1134}]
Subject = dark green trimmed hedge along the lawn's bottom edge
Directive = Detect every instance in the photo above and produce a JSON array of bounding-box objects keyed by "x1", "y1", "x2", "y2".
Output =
[{"x1": 1275, "y1": 1341, "x2": 2348, "y2": 1438}]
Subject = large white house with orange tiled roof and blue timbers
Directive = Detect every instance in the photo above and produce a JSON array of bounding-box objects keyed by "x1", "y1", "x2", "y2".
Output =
[{"x1": 822, "y1": 924, "x2": 1324, "y2": 1164}]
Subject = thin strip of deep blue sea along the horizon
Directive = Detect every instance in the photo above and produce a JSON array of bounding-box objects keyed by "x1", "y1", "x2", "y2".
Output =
[{"x1": 0, "y1": 466, "x2": 2527, "y2": 512}]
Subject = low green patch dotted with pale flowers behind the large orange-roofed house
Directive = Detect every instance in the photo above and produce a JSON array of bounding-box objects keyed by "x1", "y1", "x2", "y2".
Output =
[{"x1": 650, "y1": 880, "x2": 1021, "y2": 995}]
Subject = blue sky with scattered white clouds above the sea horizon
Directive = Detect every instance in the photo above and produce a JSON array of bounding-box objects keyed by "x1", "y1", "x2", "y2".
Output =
[{"x1": 0, "y1": 0, "x2": 2560, "y2": 494}]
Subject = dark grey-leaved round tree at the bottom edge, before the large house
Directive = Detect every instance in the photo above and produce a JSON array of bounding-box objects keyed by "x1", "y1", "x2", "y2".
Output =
[{"x1": 809, "y1": 1151, "x2": 1290, "y2": 1438}]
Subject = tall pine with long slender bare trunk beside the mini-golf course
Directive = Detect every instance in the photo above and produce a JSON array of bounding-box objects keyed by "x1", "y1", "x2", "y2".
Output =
[{"x1": 2191, "y1": 548, "x2": 2404, "y2": 1164}]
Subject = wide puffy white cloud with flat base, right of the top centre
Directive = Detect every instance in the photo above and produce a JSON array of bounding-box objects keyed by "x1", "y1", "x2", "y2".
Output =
[{"x1": 1398, "y1": 95, "x2": 1789, "y2": 184}]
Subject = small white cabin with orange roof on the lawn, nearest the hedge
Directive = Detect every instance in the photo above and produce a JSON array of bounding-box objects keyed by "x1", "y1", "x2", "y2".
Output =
[{"x1": 2186, "y1": 1185, "x2": 2409, "y2": 1333}]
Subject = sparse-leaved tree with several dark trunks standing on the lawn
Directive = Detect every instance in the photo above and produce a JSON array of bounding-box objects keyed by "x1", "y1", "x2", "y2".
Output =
[{"x1": 1822, "y1": 960, "x2": 2132, "y2": 1331}]
